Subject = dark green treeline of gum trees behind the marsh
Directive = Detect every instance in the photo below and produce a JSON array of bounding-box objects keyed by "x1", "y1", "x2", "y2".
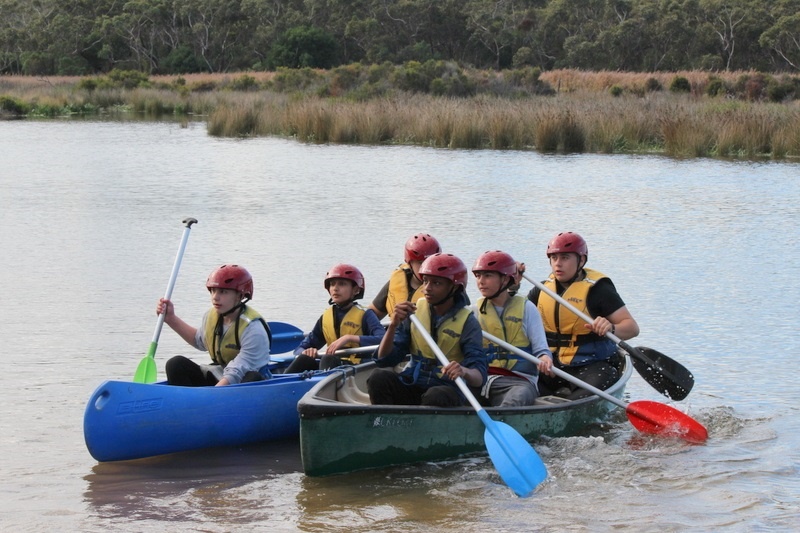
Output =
[{"x1": 0, "y1": 0, "x2": 800, "y2": 75}]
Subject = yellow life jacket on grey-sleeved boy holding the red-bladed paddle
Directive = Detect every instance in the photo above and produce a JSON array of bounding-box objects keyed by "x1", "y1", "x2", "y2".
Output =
[{"x1": 476, "y1": 296, "x2": 531, "y2": 370}]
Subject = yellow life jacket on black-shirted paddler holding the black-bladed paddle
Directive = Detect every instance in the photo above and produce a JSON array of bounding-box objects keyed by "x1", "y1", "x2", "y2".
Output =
[{"x1": 537, "y1": 268, "x2": 606, "y2": 365}]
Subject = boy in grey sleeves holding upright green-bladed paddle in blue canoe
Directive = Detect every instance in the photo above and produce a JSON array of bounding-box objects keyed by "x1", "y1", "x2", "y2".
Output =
[{"x1": 156, "y1": 265, "x2": 272, "y2": 387}]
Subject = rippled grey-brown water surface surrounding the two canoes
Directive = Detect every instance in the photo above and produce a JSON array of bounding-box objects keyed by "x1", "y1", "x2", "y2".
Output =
[{"x1": 0, "y1": 121, "x2": 800, "y2": 532}]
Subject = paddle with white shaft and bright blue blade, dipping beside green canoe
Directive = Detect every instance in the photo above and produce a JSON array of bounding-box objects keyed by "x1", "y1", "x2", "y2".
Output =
[{"x1": 409, "y1": 315, "x2": 547, "y2": 498}]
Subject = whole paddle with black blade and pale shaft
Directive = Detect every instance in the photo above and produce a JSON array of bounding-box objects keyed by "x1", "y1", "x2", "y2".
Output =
[{"x1": 522, "y1": 274, "x2": 694, "y2": 400}]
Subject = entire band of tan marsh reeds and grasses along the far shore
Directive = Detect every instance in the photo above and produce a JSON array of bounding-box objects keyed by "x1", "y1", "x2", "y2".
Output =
[{"x1": 0, "y1": 71, "x2": 800, "y2": 159}]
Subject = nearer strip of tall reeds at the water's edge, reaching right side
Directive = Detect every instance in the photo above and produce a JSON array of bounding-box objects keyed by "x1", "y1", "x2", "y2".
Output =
[{"x1": 208, "y1": 93, "x2": 800, "y2": 158}]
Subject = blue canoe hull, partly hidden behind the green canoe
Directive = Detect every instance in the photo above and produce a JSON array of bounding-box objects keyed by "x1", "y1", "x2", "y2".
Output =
[{"x1": 83, "y1": 373, "x2": 327, "y2": 461}]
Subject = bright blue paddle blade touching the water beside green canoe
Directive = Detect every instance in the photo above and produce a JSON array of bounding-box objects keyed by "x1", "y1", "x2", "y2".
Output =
[{"x1": 483, "y1": 421, "x2": 547, "y2": 498}]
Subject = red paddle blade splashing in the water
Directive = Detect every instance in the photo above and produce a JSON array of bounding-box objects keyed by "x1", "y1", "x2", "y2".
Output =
[{"x1": 625, "y1": 400, "x2": 708, "y2": 444}]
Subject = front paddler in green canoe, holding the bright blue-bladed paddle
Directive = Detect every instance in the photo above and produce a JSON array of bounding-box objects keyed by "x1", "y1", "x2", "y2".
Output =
[{"x1": 367, "y1": 253, "x2": 487, "y2": 407}]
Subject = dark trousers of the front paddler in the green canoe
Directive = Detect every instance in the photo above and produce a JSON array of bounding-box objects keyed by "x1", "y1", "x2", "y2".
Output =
[{"x1": 367, "y1": 368, "x2": 464, "y2": 407}]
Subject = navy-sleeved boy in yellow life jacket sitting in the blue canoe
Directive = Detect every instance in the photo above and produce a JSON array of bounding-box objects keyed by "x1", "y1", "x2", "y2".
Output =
[{"x1": 286, "y1": 263, "x2": 386, "y2": 374}]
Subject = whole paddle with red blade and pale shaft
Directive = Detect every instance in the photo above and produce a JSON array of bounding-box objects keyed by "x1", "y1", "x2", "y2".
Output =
[{"x1": 483, "y1": 331, "x2": 708, "y2": 444}]
